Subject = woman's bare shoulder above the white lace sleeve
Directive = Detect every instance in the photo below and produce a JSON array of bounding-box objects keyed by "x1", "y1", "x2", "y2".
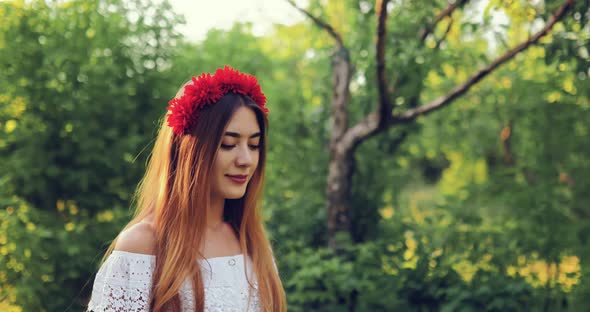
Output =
[{"x1": 115, "y1": 221, "x2": 156, "y2": 255}]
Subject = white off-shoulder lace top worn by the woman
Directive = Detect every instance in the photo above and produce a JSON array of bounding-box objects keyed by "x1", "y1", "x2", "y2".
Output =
[{"x1": 88, "y1": 250, "x2": 261, "y2": 312}]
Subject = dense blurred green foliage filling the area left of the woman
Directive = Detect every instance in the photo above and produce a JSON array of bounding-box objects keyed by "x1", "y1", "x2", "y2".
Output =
[{"x1": 0, "y1": 1, "x2": 183, "y2": 311}]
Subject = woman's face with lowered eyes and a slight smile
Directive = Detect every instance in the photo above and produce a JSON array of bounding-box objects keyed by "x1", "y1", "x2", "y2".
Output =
[{"x1": 211, "y1": 106, "x2": 261, "y2": 199}]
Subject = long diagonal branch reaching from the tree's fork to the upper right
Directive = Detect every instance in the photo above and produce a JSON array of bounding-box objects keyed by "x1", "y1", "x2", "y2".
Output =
[{"x1": 392, "y1": 0, "x2": 574, "y2": 122}]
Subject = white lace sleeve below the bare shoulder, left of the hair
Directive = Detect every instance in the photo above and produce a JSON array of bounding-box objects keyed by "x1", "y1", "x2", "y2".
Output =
[{"x1": 87, "y1": 250, "x2": 155, "y2": 312}]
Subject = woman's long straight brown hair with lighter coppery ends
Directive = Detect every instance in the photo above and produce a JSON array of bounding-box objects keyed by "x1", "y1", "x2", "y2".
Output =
[{"x1": 103, "y1": 87, "x2": 286, "y2": 312}]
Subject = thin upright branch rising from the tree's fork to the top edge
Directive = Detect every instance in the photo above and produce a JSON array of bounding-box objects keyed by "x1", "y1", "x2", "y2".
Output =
[{"x1": 375, "y1": 0, "x2": 392, "y2": 124}]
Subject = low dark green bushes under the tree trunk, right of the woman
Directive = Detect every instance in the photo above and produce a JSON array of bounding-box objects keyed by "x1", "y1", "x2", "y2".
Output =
[{"x1": 281, "y1": 235, "x2": 543, "y2": 311}]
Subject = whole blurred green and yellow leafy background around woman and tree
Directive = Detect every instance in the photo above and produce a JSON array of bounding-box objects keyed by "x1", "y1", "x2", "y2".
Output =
[{"x1": 0, "y1": 0, "x2": 590, "y2": 311}]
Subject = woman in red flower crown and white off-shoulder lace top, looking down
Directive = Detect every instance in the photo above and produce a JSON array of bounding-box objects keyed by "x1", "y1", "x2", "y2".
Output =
[{"x1": 88, "y1": 66, "x2": 286, "y2": 312}]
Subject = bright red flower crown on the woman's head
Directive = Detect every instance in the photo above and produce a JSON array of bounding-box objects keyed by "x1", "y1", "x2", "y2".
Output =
[{"x1": 167, "y1": 66, "x2": 269, "y2": 134}]
